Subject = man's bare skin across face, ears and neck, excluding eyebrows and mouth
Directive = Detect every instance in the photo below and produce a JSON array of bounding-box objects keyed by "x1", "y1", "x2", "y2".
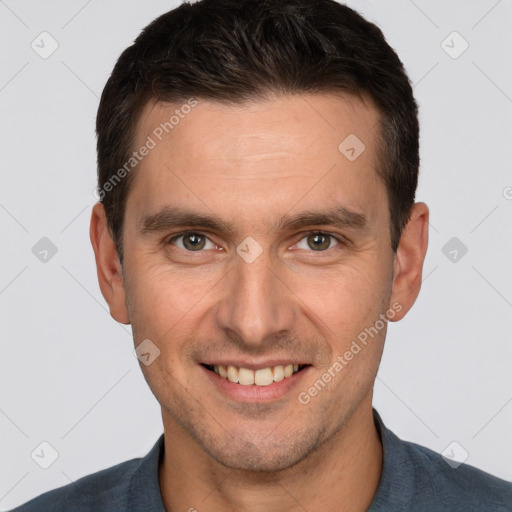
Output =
[{"x1": 91, "y1": 94, "x2": 429, "y2": 512}]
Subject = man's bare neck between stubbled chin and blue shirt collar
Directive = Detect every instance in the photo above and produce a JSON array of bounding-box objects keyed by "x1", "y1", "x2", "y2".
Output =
[{"x1": 159, "y1": 397, "x2": 383, "y2": 512}]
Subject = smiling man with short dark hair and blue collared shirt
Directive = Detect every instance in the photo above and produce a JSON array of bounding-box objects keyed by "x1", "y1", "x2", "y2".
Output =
[{"x1": 10, "y1": 0, "x2": 512, "y2": 512}]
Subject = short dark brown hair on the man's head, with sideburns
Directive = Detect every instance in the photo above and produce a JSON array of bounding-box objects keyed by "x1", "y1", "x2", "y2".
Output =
[{"x1": 96, "y1": 0, "x2": 419, "y2": 262}]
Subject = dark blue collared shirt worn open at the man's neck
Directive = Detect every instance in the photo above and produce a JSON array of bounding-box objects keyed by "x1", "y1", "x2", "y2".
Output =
[{"x1": 11, "y1": 409, "x2": 512, "y2": 512}]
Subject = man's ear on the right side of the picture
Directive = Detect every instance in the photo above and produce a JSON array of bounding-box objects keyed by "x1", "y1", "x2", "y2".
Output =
[{"x1": 390, "y1": 203, "x2": 429, "y2": 322}]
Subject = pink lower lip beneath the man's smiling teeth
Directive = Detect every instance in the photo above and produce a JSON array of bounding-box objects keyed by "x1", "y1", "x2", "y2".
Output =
[{"x1": 200, "y1": 365, "x2": 312, "y2": 403}]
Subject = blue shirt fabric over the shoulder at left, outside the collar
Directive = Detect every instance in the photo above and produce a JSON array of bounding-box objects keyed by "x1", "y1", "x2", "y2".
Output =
[{"x1": 11, "y1": 459, "x2": 141, "y2": 512}]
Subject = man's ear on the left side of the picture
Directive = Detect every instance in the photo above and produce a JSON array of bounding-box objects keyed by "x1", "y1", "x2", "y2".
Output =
[{"x1": 89, "y1": 203, "x2": 130, "y2": 324}]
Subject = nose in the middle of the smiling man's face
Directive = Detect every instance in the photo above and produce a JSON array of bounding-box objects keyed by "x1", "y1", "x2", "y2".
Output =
[{"x1": 216, "y1": 243, "x2": 298, "y2": 350}]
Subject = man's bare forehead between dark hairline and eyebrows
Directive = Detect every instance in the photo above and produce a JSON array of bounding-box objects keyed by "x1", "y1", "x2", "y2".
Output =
[{"x1": 129, "y1": 94, "x2": 386, "y2": 232}]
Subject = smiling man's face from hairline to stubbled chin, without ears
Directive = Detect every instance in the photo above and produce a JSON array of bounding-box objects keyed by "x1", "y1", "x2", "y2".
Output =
[{"x1": 124, "y1": 95, "x2": 394, "y2": 471}]
